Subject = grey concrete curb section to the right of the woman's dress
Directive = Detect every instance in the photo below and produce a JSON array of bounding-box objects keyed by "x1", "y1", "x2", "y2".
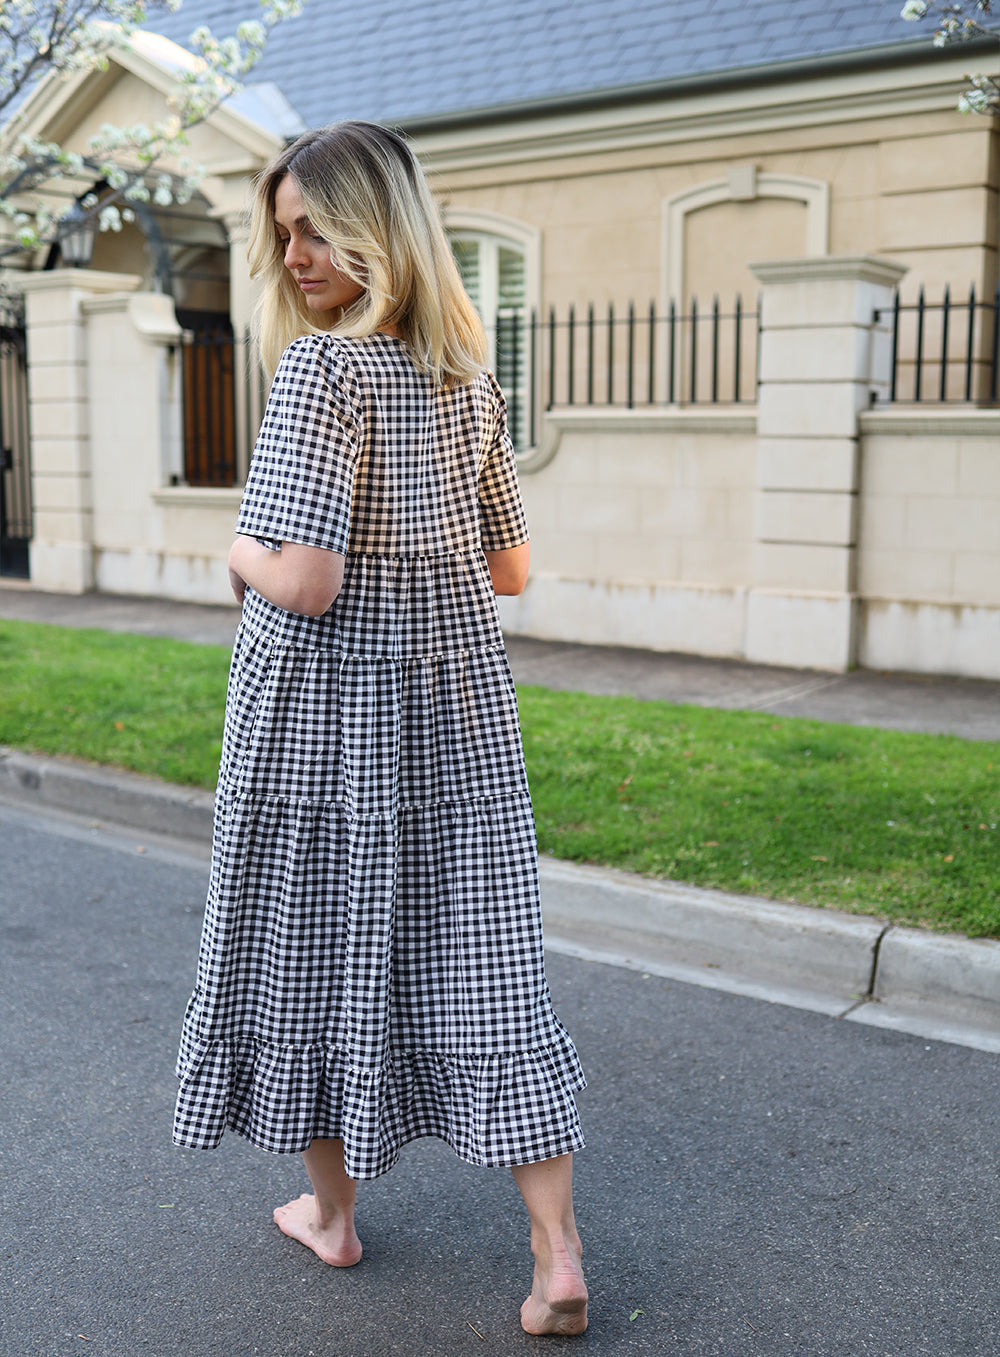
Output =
[{"x1": 541, "y1": 859, "x2": 1000, "y2": 1050}]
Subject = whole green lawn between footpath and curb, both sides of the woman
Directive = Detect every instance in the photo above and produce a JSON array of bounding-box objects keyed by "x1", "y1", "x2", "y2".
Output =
[{"x1": 0, "y1": 622, "x2": 1000, "y2": 938}]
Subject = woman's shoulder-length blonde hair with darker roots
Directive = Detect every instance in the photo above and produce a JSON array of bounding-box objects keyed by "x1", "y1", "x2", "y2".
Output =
[{"x1": 248, "y1": 122, "x2": 487, "y2": 387}]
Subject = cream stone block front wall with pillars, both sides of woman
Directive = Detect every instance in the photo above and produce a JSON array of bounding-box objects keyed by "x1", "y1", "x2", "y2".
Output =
[{"x1": 17, "y1": 256, "x2": 1000, "y2": 679}]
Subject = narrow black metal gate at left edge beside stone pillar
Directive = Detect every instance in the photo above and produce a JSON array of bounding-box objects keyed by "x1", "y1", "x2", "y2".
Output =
[{"x1": 0, "y1": 299, "x2": 31, "y2": 579}]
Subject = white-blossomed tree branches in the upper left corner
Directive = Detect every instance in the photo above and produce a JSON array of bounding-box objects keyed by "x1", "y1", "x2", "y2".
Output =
[{"x1": 0, "y1": 0, "x2": 303, "y2": 263}]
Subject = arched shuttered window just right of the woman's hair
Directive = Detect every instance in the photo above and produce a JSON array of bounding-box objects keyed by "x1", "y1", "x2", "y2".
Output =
[{"x1": 448, "y1": 213, "x2": 539, "y2": 452}]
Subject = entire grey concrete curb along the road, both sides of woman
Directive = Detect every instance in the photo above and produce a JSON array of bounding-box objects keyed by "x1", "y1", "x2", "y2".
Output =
[{"x1": 0, "y1": 748, "x2": 1000, "y2": 1050}]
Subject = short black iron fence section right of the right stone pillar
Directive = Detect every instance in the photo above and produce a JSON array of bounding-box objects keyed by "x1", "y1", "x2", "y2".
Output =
[{"x1": 875, "y1": 285, "x2": 1000, "y2": 406}]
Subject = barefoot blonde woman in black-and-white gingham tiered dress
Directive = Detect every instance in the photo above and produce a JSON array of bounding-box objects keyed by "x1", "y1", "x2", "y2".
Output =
[{"x1": 175, "y1": 122, "x2": 586, "y2": 1334}]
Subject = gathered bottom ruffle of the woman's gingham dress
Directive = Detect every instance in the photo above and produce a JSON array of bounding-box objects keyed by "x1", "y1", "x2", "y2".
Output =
[{"x1": 174, "y1": 1031, "x2": 586, "y2": 1179}]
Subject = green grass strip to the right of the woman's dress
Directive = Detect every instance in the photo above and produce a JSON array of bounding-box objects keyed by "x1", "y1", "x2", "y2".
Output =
[{"x1": 520, "y1": 688, "x2": 1000, "y2": 938}]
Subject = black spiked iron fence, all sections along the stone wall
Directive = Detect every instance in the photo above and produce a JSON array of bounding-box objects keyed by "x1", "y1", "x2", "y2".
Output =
[{"x1": 175, "y1": 286, "x2": 1000, "y2": 474}]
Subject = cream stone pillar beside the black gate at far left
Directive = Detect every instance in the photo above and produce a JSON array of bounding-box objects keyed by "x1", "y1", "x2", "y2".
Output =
[{"x1": 18, "y1": 269, "x2": 141, "y2": 593}]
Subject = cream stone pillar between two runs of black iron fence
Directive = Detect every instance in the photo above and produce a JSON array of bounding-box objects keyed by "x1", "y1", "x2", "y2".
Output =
[{"x1": 746, "y1": 255, "x2": 906, "y2": 670}]
